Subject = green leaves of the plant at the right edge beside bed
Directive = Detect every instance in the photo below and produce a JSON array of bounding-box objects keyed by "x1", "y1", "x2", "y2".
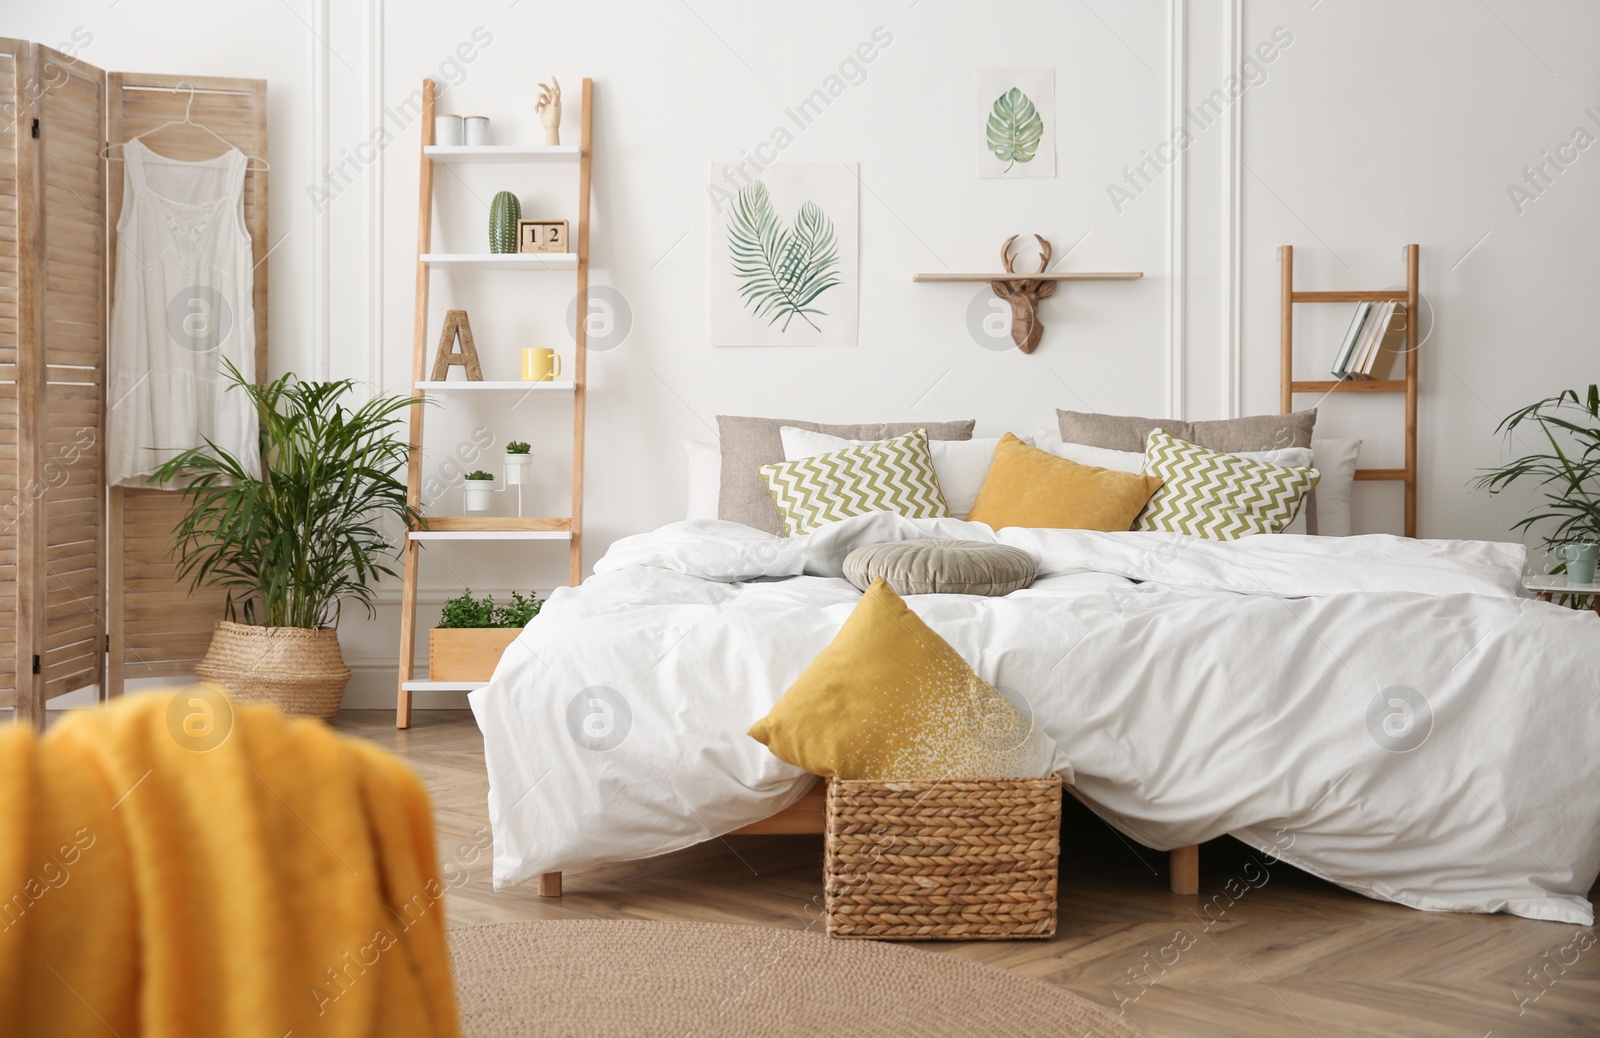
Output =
[{"x1": 1477, "y1": 385, "x2": 1600, "y2": 569}]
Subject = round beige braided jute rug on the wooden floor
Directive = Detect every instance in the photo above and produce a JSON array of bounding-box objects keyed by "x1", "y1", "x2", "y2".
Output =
[{"x1": 450, "y1": 920, "x2": 1138, "y2": 1038}]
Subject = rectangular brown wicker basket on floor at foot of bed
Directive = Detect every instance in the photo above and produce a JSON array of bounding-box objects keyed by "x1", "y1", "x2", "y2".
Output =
[{"x1": 822, "y1": 777, "x2": 1061, "y2": 940}]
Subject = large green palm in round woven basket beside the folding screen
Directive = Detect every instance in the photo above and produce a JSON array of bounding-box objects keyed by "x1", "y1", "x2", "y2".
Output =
[{"x1": 150, "y1": 365, "x2": 424, "y2": 717}]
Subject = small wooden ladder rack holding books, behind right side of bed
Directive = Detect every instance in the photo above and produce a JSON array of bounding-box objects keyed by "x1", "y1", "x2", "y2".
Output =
[{"x1": 1278, "y1": 245, "x2": 1421, "y2": 537}]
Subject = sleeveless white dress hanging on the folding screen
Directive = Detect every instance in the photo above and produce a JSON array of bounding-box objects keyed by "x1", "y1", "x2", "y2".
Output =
[{"x1": 106, "y1": 141, "x2": 261, "y2": 486}]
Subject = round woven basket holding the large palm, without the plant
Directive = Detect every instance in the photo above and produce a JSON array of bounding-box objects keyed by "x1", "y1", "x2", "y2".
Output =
[{"x1": 195, "y1": 621, "x2": 350, "y2": 718}]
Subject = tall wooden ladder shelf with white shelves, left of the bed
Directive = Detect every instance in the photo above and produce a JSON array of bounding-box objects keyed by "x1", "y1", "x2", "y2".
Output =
[{"x1": 395, "y1": 78, "x2": 594, "y2": 728}]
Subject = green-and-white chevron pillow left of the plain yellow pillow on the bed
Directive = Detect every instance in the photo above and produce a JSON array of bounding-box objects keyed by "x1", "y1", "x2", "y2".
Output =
[{"x1": 762, "y1": 429, "x2": 950, "y2": 537}]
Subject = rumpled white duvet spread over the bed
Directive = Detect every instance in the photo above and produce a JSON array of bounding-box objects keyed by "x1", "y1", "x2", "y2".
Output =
[{"x1": 470, "y1": 513, "x2": 1600, "y2": 924}]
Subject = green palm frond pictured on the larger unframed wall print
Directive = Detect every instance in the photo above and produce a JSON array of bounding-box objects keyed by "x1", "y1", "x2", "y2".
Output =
[{"x1": 728, "y1": 181, "x2": 838, "y2": 331}]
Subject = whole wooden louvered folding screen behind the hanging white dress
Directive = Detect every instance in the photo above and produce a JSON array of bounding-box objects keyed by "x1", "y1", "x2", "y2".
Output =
[{"x1": 0, "y1": 38, "x2": 270, "y2": 725}]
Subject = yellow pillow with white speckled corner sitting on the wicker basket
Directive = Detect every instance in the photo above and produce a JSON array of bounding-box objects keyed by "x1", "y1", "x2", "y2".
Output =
[{"x1": 750, "y1": 577, "x2": 1056, "y2": 780}]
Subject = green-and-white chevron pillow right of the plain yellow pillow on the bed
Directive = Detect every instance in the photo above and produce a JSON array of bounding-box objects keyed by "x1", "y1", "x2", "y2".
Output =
[{"x1": 1133, "y1": 429, "x2": 1322, "y2": 541}]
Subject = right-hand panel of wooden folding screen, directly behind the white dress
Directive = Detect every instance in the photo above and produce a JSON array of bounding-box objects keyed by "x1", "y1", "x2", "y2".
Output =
[{"x1": 106, "y1": 72, "x2": 270, "y2": 696}]
